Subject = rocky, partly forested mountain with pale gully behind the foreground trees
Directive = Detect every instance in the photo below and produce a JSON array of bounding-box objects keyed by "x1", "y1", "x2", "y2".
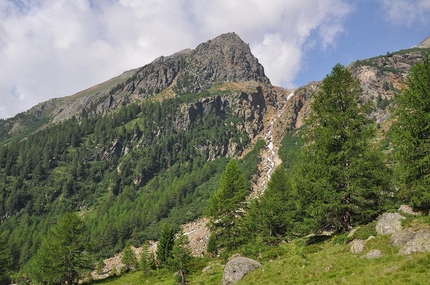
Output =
[{"x1": 0, "y1": 33, "x2": 429, "y2": 282}]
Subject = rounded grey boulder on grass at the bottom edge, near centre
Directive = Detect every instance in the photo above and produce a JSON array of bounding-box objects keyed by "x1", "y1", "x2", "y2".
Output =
[{"x1": 222, "y1": 256, "x2": 261, "y2": 285}]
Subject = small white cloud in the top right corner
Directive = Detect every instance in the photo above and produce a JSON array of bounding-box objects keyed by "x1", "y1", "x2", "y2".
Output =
[{"x1": 380, "y1": 0, "x2": 430, "y2": 27}]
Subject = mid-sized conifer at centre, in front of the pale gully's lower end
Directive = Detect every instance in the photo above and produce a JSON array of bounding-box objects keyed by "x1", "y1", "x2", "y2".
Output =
[{"x1": 207, "y1": 159, "x2": 248, "y2": 248}]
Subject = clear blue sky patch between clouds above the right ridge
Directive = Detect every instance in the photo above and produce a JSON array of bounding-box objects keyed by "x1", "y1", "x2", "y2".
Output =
[{"x1": 294, "y1": 0, "x2": 430, "y2": 86}]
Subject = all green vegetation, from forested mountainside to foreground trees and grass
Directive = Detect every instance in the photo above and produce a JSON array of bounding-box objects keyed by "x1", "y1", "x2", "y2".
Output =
[{"x1": 0, "y1": 52, "x2": 430, "y2": 284}]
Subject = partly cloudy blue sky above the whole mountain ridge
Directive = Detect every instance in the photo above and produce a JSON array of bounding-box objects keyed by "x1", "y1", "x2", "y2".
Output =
[{"x1": 0, "y1": 0, "x2": 430, "y2": 119}]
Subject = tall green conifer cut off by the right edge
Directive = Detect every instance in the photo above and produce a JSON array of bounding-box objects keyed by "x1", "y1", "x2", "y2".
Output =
[{"x1": 392, "y1": 55, "x2": 430, "y2": 213}]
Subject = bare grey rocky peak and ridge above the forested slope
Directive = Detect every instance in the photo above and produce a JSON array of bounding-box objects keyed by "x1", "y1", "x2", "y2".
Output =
[{"x1": 0, "y1": 33, "x2": 273, "y2": 144}]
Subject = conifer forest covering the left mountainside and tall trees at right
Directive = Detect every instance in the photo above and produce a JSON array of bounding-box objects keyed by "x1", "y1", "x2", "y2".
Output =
[{"x1": 0, "y1": 53, "x2": 430, "y2": 283}]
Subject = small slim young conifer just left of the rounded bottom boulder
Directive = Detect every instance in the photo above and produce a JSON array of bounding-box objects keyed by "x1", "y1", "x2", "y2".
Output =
[{"x1": 171, "y1": 231, "x2": 192, "y2": 285}]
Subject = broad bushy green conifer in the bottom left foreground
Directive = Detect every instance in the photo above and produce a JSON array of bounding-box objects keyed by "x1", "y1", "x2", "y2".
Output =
[{"x1": 27, "y1": 213, "x2": 92, "y2": 284}]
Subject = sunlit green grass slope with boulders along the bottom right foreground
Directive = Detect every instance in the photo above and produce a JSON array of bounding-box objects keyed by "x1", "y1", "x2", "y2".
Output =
[{"x1": 88, "y1": 216, "x2": 430, "y2": 285}]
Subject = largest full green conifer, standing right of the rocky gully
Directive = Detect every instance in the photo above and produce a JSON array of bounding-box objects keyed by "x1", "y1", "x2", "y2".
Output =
[{"x1": 294, "y1": 64, "x2": 388, "y2": 232}]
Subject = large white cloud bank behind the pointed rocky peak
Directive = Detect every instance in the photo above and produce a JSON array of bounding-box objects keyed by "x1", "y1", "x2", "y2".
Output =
[{"x1": 0, "y1": 0, "x2": 352, "y2": 118}]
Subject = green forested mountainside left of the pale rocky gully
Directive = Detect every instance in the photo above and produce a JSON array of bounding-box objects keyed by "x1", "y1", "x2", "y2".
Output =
[{"x1": 0, "y1": 88, "x2": 255, "y2": 282}]
